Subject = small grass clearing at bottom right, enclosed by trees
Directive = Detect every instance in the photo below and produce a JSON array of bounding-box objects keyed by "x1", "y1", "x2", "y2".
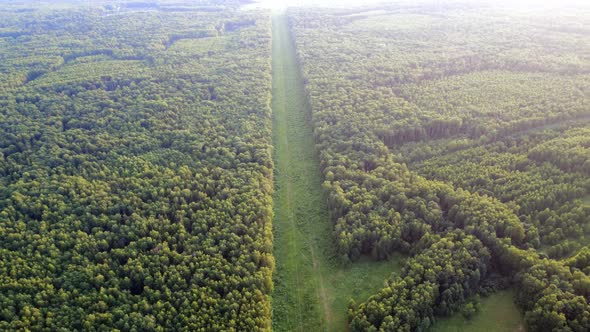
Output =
[{"x1": 430, "y1": 290, "x2": 525, "y2": 332}]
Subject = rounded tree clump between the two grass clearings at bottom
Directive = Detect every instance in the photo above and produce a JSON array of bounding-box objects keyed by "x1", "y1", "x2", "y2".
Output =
[{"x1": 350, "y1": 231, "x2": 490, "y2": 331}]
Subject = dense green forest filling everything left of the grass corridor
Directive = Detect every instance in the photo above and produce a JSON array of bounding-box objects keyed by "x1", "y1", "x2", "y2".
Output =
[{"x1": 0, "y1": 6, "x2": 274, "y2": 331}]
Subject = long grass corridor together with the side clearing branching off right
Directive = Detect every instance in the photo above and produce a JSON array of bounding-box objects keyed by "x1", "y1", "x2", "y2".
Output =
[{"x1": 272, "y1": 15, "x2": 408, "y2": 332}]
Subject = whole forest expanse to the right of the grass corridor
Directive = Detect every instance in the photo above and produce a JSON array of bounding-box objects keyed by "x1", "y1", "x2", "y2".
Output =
[{"x1": 289, "y1": 1, "x2": 590, "y2": 331}]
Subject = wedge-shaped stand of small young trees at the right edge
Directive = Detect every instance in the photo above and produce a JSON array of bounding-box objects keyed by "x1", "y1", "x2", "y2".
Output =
[{"x1": 412, "y1": 128, "x2": 590, "y2": 258}]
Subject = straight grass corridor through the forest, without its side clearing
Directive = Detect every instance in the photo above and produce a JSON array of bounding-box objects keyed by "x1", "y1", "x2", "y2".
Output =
[{"x1": 272, "y1": 11, "x2": 330, "y2": 331}]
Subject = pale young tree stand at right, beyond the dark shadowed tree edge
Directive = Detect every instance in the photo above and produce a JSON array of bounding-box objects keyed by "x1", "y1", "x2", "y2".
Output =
[{"x1": 376, "y1": 71, "x2": 590, "y2": 148}]
